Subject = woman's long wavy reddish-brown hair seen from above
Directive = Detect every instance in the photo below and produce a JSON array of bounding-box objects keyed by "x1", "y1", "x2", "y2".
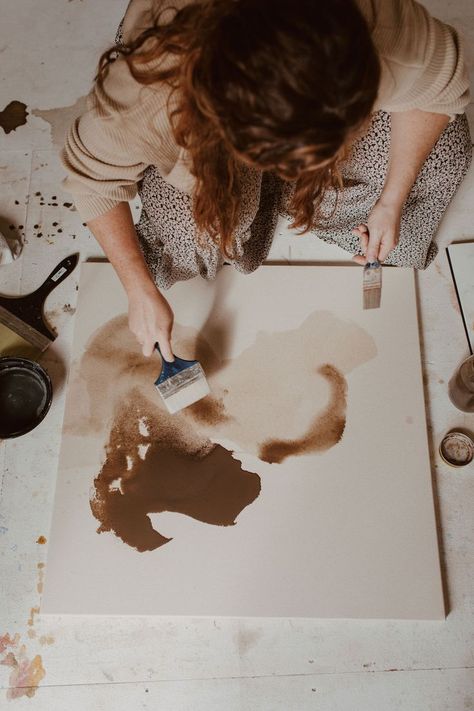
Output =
[{"x1": 96, "y1": 0, "x2": 380, "y2": 258}]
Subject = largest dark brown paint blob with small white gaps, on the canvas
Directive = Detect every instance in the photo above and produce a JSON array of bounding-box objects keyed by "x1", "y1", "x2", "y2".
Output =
[{"x1": 90, "y1": 390, "x2": 260, "y2": 552}]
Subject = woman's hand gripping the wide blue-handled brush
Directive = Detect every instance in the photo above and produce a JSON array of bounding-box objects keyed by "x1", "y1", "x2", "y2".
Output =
[{"x1": 128, "y1": 284, "x2": 173, "y2": 361}]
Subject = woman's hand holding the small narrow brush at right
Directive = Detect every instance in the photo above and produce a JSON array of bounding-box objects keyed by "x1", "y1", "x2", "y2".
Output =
[{"x1": 353, "y1": 200, "x2": 401, "y2": 264}]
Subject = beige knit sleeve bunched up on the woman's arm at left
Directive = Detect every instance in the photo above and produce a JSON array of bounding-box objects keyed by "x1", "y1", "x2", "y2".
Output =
[{"x1": 61, "y1": 59, "x2": 179, "y2": 221}]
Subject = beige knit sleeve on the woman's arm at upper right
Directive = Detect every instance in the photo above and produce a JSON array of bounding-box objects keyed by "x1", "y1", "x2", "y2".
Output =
[{"x1": 373, "y1": 0, "x2": 470, "y2": 119}]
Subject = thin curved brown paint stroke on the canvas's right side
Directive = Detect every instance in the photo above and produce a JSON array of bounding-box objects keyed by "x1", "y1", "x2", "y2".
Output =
[{"x1": 259, "y1": 364, "x2": 347, "y2": 464}]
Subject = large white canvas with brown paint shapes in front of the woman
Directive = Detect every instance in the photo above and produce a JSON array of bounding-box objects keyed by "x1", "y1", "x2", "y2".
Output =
[{"x1": 41, "y1": 263, "x2": 444, "y2": 619}]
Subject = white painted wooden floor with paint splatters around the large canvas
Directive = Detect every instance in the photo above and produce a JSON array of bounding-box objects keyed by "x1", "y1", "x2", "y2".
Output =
[{"x1": 0, "y1": 0, "x2": 474, "y2": 711}]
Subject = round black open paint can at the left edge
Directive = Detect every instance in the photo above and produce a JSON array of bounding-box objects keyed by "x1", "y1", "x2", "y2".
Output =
[{"x1": 0, "y1": 357, "x2": 53, "y2": 439}]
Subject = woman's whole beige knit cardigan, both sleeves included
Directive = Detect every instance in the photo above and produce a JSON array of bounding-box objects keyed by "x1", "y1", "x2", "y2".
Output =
[{"x1": 62, "y1": 0, "x2": 469, "y2": 221}]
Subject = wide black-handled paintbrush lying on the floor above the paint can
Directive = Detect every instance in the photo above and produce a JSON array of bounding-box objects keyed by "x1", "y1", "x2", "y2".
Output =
[{"x1": 0, "y1": 254, "x2": 79, "y2": 358}]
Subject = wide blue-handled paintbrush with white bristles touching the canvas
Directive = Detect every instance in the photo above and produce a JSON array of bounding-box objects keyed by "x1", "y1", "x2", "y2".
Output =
[{"x1": 155, "y1": 343, "x2": 210, "y2": 415}]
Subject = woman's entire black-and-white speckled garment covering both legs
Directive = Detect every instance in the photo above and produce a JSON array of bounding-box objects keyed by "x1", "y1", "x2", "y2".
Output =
[{"x1": 116, "y1": 27, "x2": 472, "y2": 288}]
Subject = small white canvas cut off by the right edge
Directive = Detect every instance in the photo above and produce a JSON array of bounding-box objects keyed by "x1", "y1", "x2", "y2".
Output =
[{"x1": 447, "y1": 242, "x2": 474, "y2": 353}]
